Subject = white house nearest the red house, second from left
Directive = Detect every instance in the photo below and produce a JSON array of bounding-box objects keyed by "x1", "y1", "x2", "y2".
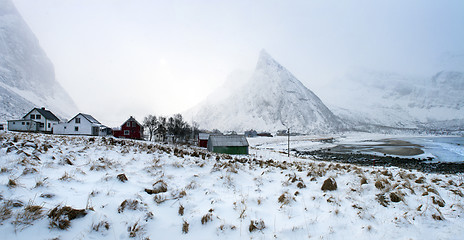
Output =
[{"x1": 53, "y1": 113, "x2": 111, "y2": 136}]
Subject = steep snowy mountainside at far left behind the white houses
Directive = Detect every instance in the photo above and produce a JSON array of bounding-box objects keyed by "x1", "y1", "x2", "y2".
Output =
[{"x1": 0, "y1": 0, "x2": 77, "y2": 121}]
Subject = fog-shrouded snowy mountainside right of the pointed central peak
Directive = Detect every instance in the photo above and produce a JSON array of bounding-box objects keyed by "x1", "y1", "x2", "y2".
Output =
[{"x1": 323, "y1": 71, "x2": 464, "y2": 131}]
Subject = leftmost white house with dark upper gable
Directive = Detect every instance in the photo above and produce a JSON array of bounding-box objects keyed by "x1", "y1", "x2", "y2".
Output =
[{"x1": 8, "y1": 108, "x2": 60, "y2": 133}]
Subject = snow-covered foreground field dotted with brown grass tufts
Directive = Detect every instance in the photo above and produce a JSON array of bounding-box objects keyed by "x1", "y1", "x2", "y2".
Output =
[{"x1": 0, "y1": 132, "x2": 464, "y2": 239}]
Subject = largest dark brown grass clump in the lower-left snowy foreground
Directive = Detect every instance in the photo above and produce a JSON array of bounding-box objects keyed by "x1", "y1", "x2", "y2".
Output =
[{"x1": 48, "y1": 205, "x2": 87, "y2": 230}]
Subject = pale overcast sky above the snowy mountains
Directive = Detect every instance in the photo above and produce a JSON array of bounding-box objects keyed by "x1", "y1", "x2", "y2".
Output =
[{"x1": 13, "y1": 0, "x2": 464, "y2": 125}]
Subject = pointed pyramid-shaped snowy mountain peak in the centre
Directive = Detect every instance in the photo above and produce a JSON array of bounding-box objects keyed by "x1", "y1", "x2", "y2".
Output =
[{"x1": 188, "y1": 50, "x2": 342, "y2": 133}]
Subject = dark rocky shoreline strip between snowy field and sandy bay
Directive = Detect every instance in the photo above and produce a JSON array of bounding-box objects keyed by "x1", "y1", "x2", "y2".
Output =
[{"x1": 293, "y1": 149, "x2": 464, "y2": 174}]
